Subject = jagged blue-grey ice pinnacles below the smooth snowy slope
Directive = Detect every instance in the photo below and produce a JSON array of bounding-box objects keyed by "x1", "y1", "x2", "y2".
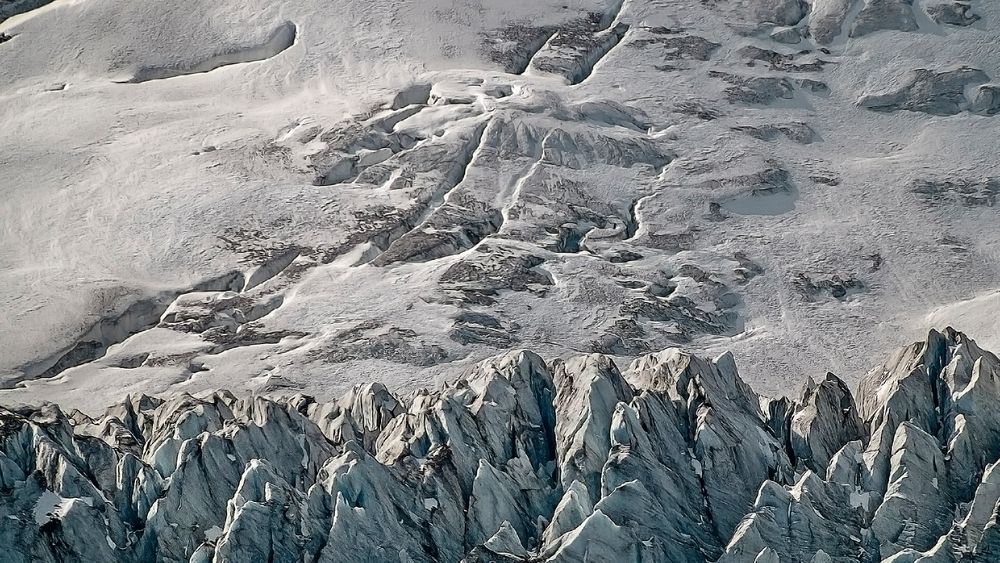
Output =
[{"x1": 0, "y1": 328, "x2": 1000, "y2": 563}]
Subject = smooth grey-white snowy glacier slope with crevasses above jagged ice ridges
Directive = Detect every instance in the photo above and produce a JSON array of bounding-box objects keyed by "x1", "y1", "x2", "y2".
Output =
[{"x1": 0, "y1": 0, "x2": 1000, "y2": 411}]
